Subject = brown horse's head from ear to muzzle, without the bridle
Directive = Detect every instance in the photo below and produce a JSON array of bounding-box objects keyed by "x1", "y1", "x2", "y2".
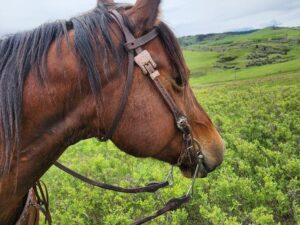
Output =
[{"x1": 95, "y1": 0, "x2": 224, "y2": 177}]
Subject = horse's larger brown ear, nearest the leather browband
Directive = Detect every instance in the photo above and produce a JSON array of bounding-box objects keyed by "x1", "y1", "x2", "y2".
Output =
[{"x1": 128, "y1": 0, "x2": 161, "y2": 36}]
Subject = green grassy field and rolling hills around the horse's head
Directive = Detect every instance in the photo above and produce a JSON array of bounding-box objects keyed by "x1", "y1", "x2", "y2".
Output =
[{"x1": 43, "y1": 28, "x2": 300, "y2": 225}]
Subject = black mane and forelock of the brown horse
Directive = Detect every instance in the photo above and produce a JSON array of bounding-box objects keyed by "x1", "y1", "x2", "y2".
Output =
[{"x1": 0, "y1": 2, "x2": 186, "y2": 175}]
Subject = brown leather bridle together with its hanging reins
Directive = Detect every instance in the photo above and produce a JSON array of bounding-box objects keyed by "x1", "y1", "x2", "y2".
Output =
[{"x1": 54, "y1": 10, "x2": 204, "y2": 225}]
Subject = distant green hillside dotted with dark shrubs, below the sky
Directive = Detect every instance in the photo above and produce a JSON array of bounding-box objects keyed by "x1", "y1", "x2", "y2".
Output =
[{"x1": 179, "y1": 27, "x2": 300, "y2": 84}]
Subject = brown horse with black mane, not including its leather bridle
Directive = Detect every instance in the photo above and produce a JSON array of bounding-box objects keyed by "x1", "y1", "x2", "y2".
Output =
[{"x1": 0, "y1": 0, "x2": 224, "y2": 225}]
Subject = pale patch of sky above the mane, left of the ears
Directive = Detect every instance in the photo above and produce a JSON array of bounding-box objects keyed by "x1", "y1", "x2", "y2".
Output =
[{"x1": 0, "y1": 0, "x2": 96, "y2": 32}]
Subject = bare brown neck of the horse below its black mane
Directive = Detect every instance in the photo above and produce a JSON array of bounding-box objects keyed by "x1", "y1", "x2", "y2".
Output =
[{"x1": 0, "y1": 34, "x2": 110, "y2": 224}]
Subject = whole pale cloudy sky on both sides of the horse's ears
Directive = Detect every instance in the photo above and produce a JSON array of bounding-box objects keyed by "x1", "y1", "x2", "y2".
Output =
[{"x1": 0, "y1": 0, "x2": 300, "y2": 36}]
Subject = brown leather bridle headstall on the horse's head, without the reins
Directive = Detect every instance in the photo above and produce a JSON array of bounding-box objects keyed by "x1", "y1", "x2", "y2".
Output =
[{"x1": 101, "y1": 10, "x2": 202, "y2": 166}]
